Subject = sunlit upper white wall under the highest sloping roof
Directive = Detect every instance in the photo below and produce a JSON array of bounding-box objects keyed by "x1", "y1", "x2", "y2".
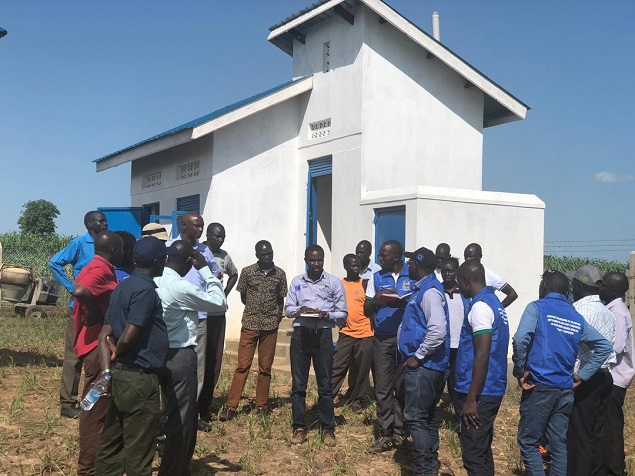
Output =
[{"x1": 356, "y1": 11, "x2": 483, "y2": 190}]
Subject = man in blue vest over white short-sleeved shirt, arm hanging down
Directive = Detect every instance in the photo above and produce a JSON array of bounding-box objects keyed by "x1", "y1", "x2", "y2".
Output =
[{"x1": 454, "y1": 260, "x2": 509, "y2": 476}]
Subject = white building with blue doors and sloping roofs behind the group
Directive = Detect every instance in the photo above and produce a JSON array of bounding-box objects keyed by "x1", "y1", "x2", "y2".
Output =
[{"x1": 96, "y1": 0, "x2": 544, "y2": 350}]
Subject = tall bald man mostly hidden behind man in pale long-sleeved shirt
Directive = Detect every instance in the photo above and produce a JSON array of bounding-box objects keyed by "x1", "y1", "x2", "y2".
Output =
[{"x1": 166, "y1": 212, "x2": 222, "y2": 431}]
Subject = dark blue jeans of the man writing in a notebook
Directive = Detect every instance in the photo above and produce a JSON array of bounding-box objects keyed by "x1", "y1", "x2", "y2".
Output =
[{"x1": 291, "y1": 327, "x2": 335, "y2": 431}]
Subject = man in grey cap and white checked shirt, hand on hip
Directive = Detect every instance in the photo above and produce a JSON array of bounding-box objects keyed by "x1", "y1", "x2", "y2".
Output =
[{"x1": 567, "y1": 265, "x2": 615, "y2": 476}]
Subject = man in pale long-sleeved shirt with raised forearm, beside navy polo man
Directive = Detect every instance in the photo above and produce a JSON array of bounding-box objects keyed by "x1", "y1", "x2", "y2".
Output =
[{"x1": 154, "y1": 240, "x2": 227, "y2": 476}]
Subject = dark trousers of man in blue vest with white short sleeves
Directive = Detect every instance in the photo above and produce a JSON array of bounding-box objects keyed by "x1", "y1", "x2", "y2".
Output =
[{"x1": 457, "y1": 393, "x2": 503, "y2": 476}]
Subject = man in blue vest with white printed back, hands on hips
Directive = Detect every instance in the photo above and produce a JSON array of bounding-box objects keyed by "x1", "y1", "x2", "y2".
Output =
[{"x1": 512, "y1": 271, "x2": 612, "y2": 476}]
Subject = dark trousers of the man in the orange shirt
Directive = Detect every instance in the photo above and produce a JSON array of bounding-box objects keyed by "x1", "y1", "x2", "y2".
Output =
[{"x1": 332, "y1": 332, "x2": 373, "y2": 401}]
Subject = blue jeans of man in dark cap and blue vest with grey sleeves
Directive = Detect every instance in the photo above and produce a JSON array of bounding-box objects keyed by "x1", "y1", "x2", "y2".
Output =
[{"x1": 403, "y1": 366, "x2": 445, "y2": 475}]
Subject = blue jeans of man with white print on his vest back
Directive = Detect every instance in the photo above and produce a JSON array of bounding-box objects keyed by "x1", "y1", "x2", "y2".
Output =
[{"x1": 518, "y1": 384, "x2": 573, "y2": 476}]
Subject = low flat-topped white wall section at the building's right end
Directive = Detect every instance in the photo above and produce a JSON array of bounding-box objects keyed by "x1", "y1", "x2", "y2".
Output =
[{"x1": 362, "y1": 186, "x2": 545, "y2": 355}]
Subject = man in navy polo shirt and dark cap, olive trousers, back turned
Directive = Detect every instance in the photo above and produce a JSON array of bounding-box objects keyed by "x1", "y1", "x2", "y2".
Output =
[{"x1": 96, "y1": 237, "x2": 176, "y2": 476}]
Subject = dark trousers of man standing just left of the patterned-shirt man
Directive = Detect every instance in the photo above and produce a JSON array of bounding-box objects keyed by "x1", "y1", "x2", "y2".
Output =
[{"x1": 198, "y1": 316, "x2": 227, "y2": 415}]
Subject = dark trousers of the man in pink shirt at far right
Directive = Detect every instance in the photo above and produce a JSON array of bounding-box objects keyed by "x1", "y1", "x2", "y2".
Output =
[{"x1": 604, "y1": 385, "x2": 626, "y2": 476}]
